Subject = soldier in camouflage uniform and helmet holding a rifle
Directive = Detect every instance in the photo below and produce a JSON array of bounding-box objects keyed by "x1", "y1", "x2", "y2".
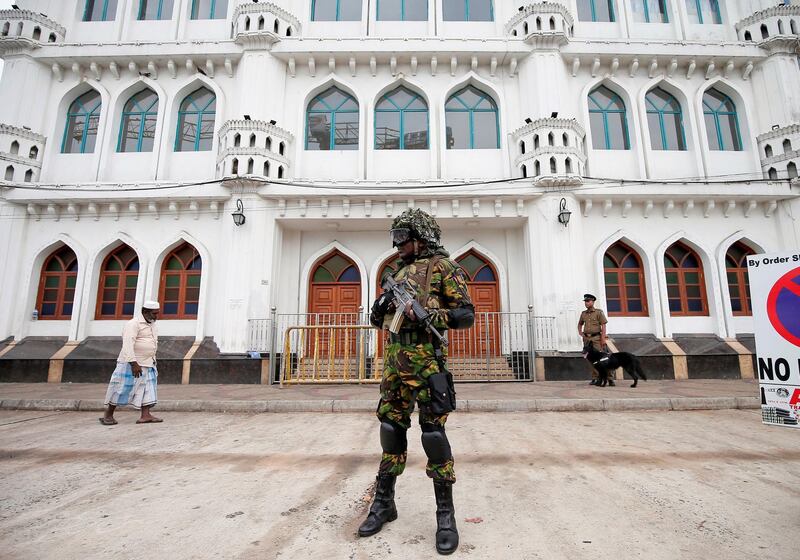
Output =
[{"x1": 358, "y1": 209, "x2": 475, "y2": 554}]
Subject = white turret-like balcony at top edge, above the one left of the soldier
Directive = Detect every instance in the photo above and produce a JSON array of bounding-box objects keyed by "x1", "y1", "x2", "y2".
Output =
[{"x1": 233, "y1": 2, "x2": 301, "y2": 48}]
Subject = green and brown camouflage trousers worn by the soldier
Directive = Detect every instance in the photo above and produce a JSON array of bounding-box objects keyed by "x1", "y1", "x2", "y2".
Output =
[{"x1": 376, "y1": 343, "x2": 456, "y2": 482}]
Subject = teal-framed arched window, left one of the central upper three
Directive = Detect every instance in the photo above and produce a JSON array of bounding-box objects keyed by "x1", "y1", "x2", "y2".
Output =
[{"x1": 306, "y1": 87, "x2": 358, "y2": 150}]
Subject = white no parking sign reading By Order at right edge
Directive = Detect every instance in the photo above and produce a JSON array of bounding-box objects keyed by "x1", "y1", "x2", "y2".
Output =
[{"x1": 747, "y1": 252, "x2": 800, "y2": 428}]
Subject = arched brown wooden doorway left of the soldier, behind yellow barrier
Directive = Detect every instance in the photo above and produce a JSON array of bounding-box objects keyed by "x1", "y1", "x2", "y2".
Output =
[{"x1": 308, "y1": 249, "x2": 361, "y2": 356}]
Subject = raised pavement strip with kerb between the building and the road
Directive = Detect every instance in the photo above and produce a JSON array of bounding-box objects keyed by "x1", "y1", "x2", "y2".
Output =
[{"x1": 0, "y1": 379, "x2": 760, "y2": 412}]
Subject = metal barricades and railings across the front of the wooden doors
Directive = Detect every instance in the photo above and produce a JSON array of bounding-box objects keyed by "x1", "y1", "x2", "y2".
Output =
[{"x1": 248, "y1": 308, "x2": 558, "y2": 383}]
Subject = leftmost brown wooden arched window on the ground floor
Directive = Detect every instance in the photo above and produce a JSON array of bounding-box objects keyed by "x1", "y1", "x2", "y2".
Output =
[{"x1": 36, "y1": 245, "x2": 78, "y2": 320}]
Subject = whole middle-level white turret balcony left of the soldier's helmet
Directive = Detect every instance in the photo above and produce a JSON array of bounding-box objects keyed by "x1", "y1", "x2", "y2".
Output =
[{"x1": 217, "y1": 120, "x2": 294, "y2": 179}]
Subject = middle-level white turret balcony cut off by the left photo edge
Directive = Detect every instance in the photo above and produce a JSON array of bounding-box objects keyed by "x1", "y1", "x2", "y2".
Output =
[{"x1": 0, "y1": 124, "x2": 47, "y2": 183}]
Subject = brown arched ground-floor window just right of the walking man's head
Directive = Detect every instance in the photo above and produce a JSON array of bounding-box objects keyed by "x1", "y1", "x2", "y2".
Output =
[{"x1": 158, "y1": 242, "x2": 203, "y2": 319}]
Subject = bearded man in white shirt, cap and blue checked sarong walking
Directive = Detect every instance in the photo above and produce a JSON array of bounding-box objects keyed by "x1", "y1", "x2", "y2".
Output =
[{"x1": 100, "y1": 301, "x2": 162, "y2": 426}]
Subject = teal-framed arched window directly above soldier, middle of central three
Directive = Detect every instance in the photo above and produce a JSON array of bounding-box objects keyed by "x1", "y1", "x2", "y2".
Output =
[{"x1": 375, "y1": 86, "x2": 428, "y2": 150}]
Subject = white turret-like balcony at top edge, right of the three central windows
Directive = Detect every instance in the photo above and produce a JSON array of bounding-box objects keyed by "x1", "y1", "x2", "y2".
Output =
[{"x1": 505, "y1": 2, "x2": 573, "y2": 48}]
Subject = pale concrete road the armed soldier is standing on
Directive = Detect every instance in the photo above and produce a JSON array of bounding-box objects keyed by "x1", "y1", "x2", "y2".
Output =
[{"x1": 0, "y1": 410, "x2": 800, "y2": 560}]
